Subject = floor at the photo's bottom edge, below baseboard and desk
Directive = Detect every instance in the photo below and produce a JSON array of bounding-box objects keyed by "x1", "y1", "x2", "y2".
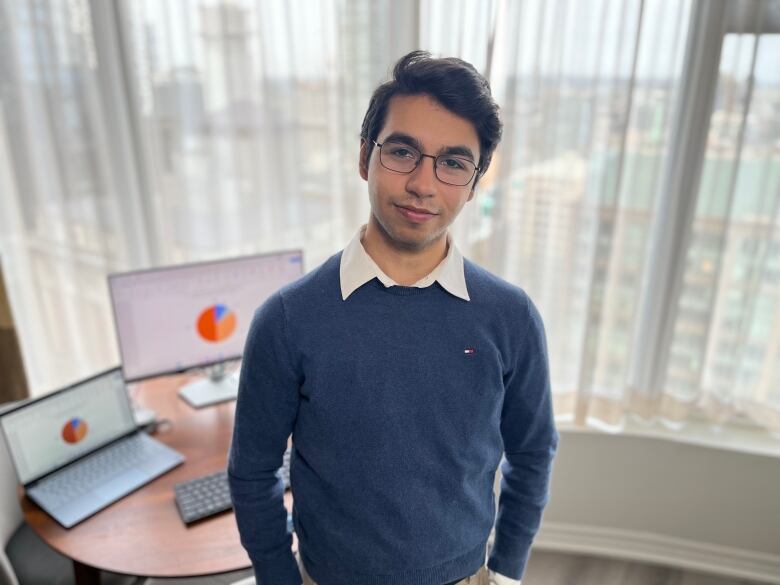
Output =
[{"x1": 142, "y1": 551, "x2": 759, "y2": 585}]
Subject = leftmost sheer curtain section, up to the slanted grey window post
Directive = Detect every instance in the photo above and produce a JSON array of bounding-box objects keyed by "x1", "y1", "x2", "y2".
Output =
[{"x1": 0, "y1": 2, "x2": 139, "y2": 392}]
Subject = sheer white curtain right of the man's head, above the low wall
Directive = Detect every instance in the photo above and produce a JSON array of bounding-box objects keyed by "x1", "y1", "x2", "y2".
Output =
[{"x1": 421, "y1": 0, "x2": 780, "y2": 432}]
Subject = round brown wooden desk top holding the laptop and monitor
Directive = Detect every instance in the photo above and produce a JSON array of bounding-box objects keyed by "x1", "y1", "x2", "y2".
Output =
[{"x1": 21, "y1": 376, "x2": 297, "y2": 585}]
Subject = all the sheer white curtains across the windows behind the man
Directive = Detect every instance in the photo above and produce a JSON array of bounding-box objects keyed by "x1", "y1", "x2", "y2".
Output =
[{"x1": 0, "y1": 0, "x2": 780, "y2": 431}]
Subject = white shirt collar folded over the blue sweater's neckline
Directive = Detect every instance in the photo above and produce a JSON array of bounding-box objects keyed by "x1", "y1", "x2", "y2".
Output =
[{"x1": 339, "y1": 225, "x2": 471, "y2": 301}]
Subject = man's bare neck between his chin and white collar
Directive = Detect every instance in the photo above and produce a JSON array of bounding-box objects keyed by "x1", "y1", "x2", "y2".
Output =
[{"x1": 361, "y1": 221, "x2": 447, "y2": 286}]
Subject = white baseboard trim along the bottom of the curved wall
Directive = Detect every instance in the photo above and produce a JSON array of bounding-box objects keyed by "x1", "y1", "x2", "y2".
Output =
[{"x1": 534, "y1": 522, "x2": 780, "y2": 585}]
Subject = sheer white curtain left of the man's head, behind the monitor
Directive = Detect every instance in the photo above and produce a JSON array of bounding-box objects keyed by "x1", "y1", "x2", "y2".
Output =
[{"x1": 0, "y1": 0, "x2": 417, "y2": 393}]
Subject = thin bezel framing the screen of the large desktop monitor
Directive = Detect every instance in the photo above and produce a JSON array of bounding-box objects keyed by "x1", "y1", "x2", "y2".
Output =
[{"x1": 106, "y1": 248, "x2": 306, "y2": 384}]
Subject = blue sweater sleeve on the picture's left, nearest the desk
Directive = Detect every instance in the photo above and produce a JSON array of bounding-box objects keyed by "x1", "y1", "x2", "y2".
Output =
[{"x1": 228, "y1": 293, "x2": 302, "y2": 585}]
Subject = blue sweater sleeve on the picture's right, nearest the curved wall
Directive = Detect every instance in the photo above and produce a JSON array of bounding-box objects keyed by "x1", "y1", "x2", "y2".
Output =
[{"x1": 488, "y1": 299, "x2": 558, "y2": 579}]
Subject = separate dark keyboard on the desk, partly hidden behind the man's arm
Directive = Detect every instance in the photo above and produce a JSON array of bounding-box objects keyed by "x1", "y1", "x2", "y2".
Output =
[{"x1": 173, "y1": 448, "x2": 290, "y2": 524}]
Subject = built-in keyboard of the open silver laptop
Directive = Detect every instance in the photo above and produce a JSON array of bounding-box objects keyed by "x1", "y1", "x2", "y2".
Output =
[{"x1": 36, "y1": 433, "x2": 168, "y2": 507}]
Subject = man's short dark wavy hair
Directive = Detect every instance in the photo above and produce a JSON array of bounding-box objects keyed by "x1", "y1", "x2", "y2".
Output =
[{"x1": 360, "y1": 51, "x2": 501, "y2": 185}]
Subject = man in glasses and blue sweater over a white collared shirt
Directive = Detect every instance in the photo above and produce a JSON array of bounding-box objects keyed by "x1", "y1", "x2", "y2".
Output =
[{"x1": 229, "y1": 51, "x2": 558, "y2": 585}]
